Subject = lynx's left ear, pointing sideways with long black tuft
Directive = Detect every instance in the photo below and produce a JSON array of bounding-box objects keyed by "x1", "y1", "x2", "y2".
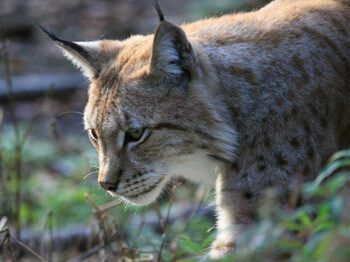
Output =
[{"x1": 38, "y1": 25, "x2": 105, "y2": 79}]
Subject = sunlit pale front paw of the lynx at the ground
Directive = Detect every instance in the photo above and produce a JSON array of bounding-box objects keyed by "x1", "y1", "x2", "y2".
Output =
[{"x1": 208, "y1": 234, "x2": 234, "y2": 260}]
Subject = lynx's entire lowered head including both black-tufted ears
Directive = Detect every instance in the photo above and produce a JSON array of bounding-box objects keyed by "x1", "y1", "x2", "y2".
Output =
[{"x1": 42, "y1": 8, "x2": 235, "y2": 205}]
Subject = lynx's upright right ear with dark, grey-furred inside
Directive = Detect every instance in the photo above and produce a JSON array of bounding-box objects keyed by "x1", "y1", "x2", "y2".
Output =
[{"x1": 151, "y1": 20, "x2": 194, "y2": 77}]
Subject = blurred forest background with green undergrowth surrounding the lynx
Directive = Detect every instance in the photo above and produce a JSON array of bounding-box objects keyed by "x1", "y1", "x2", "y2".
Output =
[{"x1": 0, "y1": 0, "x2": 350, "y2": 261}]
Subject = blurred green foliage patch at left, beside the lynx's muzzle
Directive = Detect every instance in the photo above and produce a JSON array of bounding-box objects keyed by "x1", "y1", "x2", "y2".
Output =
[{"x1": 0, "y1": 124, "x2": 101, "y2": 226}]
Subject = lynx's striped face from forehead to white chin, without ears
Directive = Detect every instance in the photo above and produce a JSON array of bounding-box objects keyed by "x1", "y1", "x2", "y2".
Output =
[{"x1": 84, "y1": 65, "x2": 230, "y2": 205}]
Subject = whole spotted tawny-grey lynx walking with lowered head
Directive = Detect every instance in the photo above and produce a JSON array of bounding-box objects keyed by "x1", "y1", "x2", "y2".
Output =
[{"x1": 42, "y1": 0, "x2": 350, "y2": 259}]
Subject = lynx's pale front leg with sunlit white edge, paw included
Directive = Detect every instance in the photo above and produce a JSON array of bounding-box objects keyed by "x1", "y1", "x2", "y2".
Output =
[{"x1": 209, "y1": 174, "x2": 253, "y2": 259}]
